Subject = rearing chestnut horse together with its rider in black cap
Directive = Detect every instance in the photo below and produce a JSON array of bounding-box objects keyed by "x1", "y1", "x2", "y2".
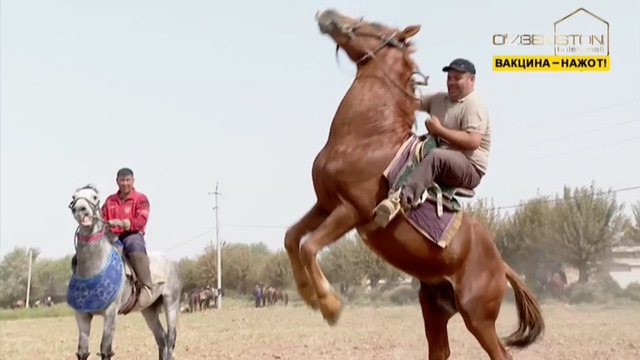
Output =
[{"x1": 284, "y1": 9, "x2": 545, "y2": 359}]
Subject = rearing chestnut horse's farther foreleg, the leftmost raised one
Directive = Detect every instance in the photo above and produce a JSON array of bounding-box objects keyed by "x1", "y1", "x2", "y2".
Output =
[{"x1": 282, "y1": 204, "x2": 327, "y2": 309}]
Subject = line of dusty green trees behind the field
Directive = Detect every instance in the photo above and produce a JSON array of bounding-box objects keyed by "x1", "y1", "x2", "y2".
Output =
[{"x1": 0, "y1": 185, "x2": 640, "y2": 307}]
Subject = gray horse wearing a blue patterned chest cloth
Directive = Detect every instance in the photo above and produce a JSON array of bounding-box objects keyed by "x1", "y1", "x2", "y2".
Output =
[{"x1": 67, "y1": 184, "x2": 182, "y2": 360}]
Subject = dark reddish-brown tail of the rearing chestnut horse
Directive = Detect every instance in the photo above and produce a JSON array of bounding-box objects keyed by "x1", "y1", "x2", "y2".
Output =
[{"x1": 504, "y1": 263, "x2": 545, "y2": 348}]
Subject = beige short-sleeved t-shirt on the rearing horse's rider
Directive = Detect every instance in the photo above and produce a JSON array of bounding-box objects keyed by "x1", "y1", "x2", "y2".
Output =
[{"x1": 420, "y1": 91, "x2": 491, "y2": 174}]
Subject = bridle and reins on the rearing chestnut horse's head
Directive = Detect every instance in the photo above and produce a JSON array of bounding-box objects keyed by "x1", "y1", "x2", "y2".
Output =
[{"x1": 336, "y1": 18, "x2": 429, "y2": 101}]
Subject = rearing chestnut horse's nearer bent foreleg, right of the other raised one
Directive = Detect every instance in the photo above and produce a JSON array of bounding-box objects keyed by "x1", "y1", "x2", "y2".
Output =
[{"x1": 300, "y1": 205, "x2": 357, "y2": 325}]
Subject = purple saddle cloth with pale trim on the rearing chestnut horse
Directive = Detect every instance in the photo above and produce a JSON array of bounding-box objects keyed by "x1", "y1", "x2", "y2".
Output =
[{"x1": 384, "y1": 135, "x2": 475, "y2": 248}]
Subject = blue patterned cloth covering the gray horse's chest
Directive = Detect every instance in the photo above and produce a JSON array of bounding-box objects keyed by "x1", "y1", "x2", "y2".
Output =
[{"x1": 67, "y1": 248, "x2": 124, "y2": 312}]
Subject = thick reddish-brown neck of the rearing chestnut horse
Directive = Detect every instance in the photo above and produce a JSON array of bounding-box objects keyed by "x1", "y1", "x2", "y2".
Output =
[{"x1": 329, "y1": 48, "x2": 418, "y2": 146}]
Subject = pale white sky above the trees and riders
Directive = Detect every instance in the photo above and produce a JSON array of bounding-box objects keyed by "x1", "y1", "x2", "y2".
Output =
[{"x1": 0, "y1": 0, "x2": 640, "y2": 258}]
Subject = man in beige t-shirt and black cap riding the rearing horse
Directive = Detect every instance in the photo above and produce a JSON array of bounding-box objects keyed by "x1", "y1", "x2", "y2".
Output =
[{"x1": 401, "y1": 59, "x2": 491, "y2": 217}]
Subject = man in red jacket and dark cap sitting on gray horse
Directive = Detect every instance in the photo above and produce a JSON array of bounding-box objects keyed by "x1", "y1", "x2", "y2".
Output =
[{"x1": 71, "y1": 168, "x2": 152, "y2": 307}]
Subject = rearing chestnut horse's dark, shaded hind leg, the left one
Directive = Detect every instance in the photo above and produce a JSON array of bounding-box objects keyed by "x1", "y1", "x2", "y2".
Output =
[{"x1": 419, "y1": 282, "x2": 457, "y2": 360}]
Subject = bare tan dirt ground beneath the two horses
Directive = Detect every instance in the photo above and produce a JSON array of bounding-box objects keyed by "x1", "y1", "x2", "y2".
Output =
[{"x1": 0, "y1": 303, "x2": 640, "y2": 360}]
